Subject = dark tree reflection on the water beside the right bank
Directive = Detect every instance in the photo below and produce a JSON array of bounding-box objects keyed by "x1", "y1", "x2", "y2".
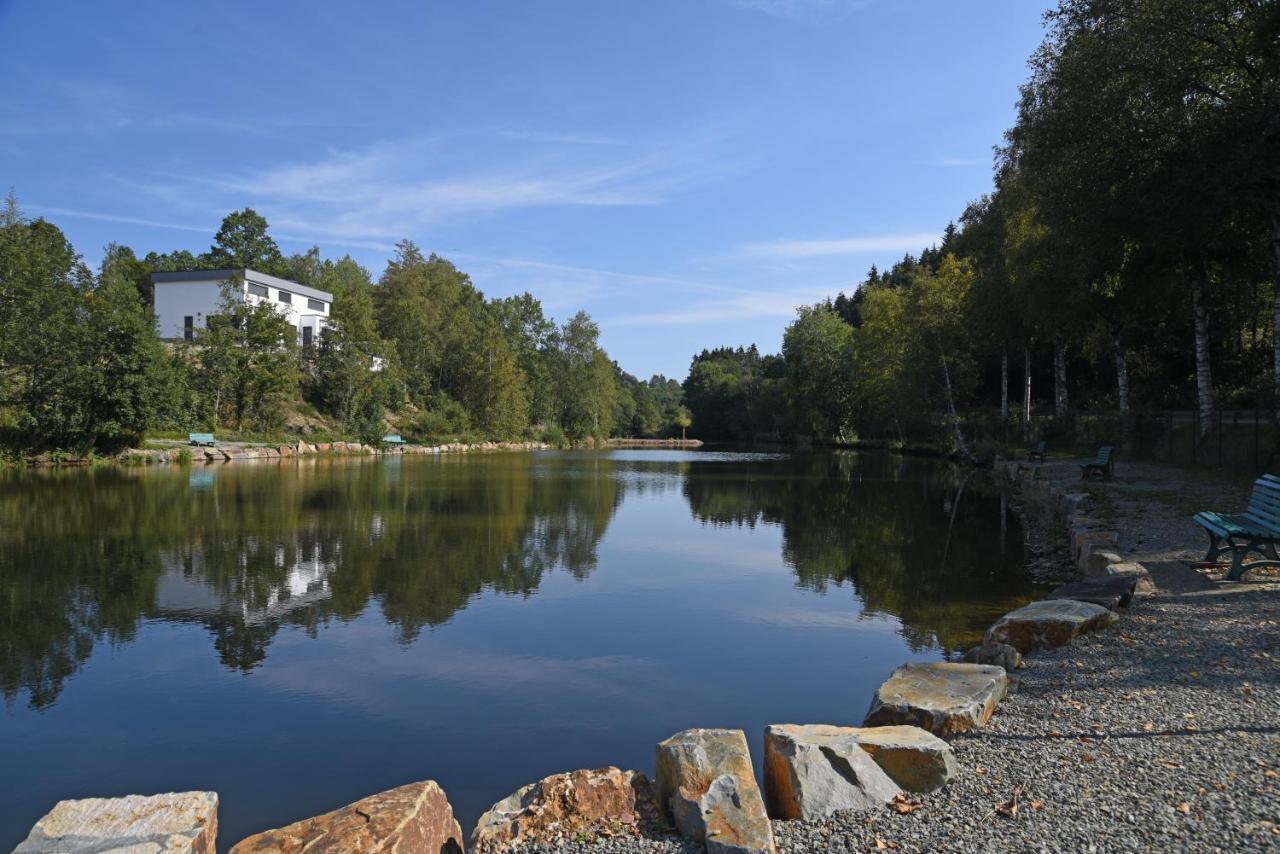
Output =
[{"x1": 685, "y1": 453, "x2": 1029, "y2": 650}]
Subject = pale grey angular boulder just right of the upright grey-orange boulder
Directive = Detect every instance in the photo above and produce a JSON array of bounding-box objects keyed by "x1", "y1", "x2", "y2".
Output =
[{"x1": 764, "y1": 723, "x2": 902, "y2": 821}]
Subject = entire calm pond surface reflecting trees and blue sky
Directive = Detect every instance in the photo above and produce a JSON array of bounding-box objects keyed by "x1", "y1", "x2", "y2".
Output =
[{"x1": 0, "y1": 451, "x2": 1030, "y2": 846}]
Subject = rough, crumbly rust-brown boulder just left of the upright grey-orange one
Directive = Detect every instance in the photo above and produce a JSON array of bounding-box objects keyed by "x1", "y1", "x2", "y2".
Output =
[{"x1": 471, "y1": 767, "x2": 667, "y2": 854}]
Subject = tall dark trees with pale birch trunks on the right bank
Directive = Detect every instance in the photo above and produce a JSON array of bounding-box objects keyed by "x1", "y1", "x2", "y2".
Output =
[{"x1": 685, "y1": 0, "x2": 1280, "y2": 451}]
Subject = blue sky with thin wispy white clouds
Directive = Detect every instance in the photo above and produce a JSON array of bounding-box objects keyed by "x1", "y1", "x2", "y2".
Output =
[{"x1": 0, "y1": 0, "x2": 1043, "y2": 378}]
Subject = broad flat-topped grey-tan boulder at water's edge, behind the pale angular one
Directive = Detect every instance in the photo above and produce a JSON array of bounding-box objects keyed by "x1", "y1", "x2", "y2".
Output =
[{"x1": 863, "y1": 662, "x2": 1009, "y2": 737}]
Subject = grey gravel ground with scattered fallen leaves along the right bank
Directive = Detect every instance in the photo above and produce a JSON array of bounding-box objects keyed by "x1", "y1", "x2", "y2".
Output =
[{"x1": 521, "y1": 462, "x2": 1280, "y2": 854}]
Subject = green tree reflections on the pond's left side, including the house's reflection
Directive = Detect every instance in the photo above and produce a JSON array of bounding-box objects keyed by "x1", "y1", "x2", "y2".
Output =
[{"x1": 0, "y1": 455, "x2": 622, "y2": 708}]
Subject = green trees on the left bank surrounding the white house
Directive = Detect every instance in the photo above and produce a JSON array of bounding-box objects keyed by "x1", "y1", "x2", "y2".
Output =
[{"x1": 0, "y1": 202, "x2": 689, "y2": 452}]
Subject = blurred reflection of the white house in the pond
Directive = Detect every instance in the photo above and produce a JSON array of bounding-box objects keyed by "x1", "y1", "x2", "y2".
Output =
[{"x1": 156, "y1": 538, "x2": 338, "y2": 625}]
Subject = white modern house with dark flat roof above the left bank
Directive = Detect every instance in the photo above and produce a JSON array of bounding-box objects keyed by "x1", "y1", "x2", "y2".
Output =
[{"x1": 151, "y1": 269, "x2": 333, "y2": 346}]
